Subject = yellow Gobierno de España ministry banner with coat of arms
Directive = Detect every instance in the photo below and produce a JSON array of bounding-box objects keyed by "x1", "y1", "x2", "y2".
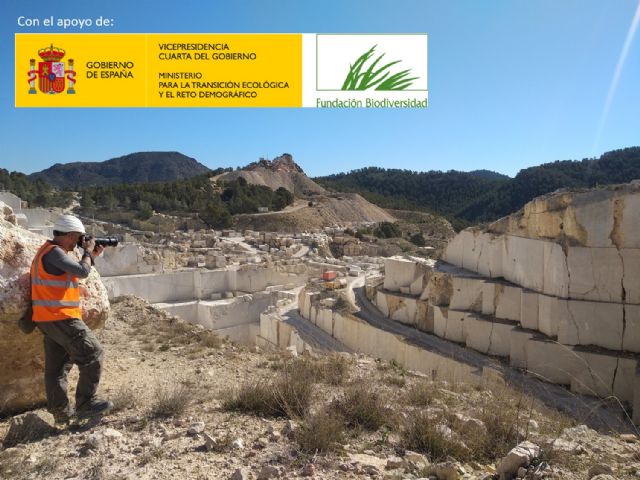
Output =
[{"x1": 15, "y1": 34, "x2": 302, "y2": 107}]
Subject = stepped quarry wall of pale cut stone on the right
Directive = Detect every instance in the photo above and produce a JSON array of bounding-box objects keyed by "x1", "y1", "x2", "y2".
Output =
[{"x1": 367, "y1": 183, "x2": 640, "y2": 422}]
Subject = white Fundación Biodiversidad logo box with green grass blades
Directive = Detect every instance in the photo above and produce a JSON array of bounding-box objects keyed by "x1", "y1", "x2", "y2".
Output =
[{"x1": 316, "y1": 34, "x2": 428, "y2": 108}]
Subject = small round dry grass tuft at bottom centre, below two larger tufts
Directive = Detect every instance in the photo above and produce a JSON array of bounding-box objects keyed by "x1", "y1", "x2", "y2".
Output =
[{"x1": 295, "y1": 409, "x2": 344, "y2": 454}]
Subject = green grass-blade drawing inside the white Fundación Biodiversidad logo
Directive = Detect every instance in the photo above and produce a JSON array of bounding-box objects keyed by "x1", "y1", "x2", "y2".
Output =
[{"x1": 342, "y1": 45, "x2": 419, "y2": 90}]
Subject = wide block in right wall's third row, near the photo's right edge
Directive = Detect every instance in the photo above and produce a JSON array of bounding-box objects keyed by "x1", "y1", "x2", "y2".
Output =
[{"x1": 558, "y1": 300, "x2": 623, "y2": 350}]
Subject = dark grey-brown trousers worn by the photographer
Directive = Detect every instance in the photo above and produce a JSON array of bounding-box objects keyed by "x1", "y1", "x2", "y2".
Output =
[{"x1": 37, "y1": 318, "x2": 103, "y2": 412}]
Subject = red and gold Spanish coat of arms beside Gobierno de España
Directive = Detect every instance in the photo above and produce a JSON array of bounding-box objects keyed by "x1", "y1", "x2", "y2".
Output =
[{"x1": 27, "y1": 44, "x2": 76, "y2": 95}]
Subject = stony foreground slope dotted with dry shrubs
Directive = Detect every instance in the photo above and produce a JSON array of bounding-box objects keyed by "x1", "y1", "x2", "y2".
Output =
[{"x1": 0, "y1": 297, "x2": 640, "y2": 480}]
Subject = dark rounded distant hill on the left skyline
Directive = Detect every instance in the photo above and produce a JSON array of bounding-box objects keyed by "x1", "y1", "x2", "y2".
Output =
[{"x1": 29, "y1": 152, "x2": 211, "y2": 188}]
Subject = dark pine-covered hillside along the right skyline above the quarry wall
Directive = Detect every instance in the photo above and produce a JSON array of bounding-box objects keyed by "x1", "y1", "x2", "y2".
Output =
[{"x1": 314, "y1": 147, "x2": 640, "y2": 227}]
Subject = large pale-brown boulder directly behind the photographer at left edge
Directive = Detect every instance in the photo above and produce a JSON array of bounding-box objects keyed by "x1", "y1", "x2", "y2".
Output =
[{"x1": 0, "y1": 219, "x2": 109, "y2": 415}]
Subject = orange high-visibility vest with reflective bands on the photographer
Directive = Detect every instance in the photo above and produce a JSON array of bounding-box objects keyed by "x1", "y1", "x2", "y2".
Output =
[{"x1": 31, "y1": 240, "x2": 82, "y2": 322}]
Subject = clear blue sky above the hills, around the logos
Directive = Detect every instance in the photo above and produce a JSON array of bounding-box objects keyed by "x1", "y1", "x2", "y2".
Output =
[{"x1": 0, "y1": 0, "x2": 640, "y2": 176}]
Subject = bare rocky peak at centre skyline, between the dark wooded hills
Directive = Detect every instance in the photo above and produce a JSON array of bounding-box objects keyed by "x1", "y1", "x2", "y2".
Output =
[{"x1": 212, "y1": 153, "x2": 326, "y2": 197}]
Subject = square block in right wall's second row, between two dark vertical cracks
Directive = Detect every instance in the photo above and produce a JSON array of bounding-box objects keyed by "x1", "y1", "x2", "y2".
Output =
[{"x1": 567, "y1": 247, "x2": 622, "y2": 303}]
